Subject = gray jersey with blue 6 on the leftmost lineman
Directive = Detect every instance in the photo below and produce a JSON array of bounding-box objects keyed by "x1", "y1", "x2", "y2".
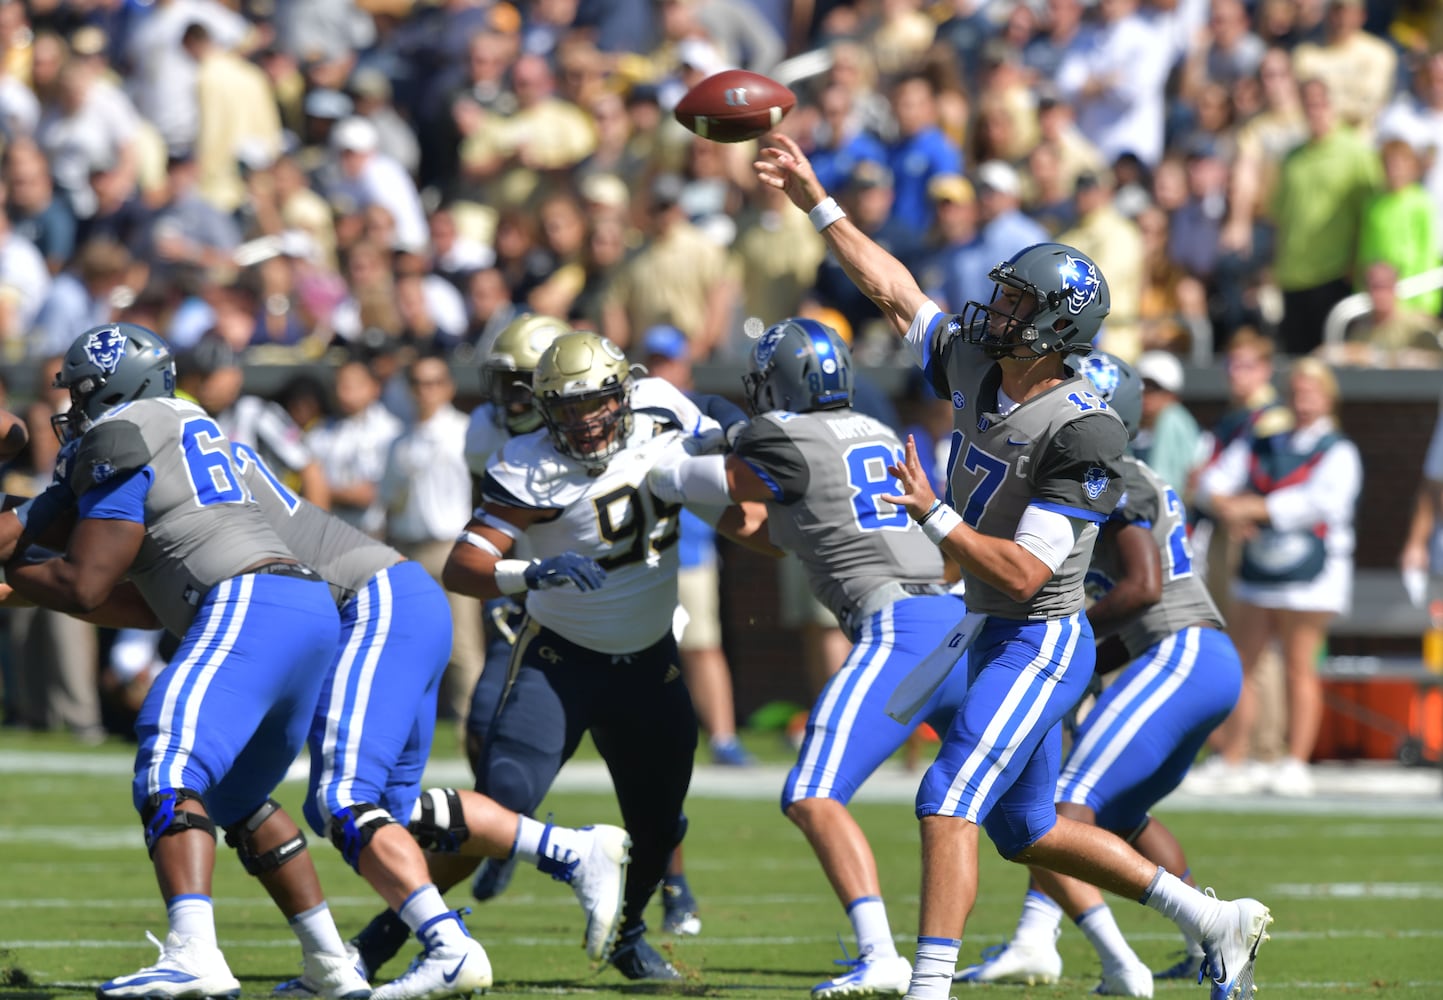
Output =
[{"x1": 71, "y1": 398, "x2": 294, "y2": 635}]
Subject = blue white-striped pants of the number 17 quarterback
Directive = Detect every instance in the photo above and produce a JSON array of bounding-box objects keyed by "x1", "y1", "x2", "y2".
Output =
[{"x1": 916, "y1": 612, "x2": 1097, "y2": 857}]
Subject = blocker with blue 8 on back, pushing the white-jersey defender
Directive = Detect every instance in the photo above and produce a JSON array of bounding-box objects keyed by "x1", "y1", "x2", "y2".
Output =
[{"x1": 648, "y1": 319, "x2": 967, "y2": 997}]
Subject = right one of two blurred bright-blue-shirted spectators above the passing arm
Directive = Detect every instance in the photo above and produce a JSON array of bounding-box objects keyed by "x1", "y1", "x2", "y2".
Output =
[{"x1": 887, "y1": 74, "x2": 962, "y2": 240}]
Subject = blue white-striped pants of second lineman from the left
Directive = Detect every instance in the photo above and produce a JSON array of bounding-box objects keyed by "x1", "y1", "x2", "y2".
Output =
[{"x1": 304, "y1": 561, "x2": 452, "y2": 835}]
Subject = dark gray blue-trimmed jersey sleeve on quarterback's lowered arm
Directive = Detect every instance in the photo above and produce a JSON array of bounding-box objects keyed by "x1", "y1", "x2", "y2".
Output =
[{"x1": 1032, "y1": 411, "x2": 1127, "y2": 522}]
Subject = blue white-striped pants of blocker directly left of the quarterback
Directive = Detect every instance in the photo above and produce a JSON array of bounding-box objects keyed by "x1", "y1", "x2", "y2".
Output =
[{"x1": 782, "y1": 596, "x2": 967, "y2": 812}]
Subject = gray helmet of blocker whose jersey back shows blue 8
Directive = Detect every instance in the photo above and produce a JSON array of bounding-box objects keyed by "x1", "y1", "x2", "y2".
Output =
[{"x1": 742, "y1": 317, "x2": 851, "y2": 413}]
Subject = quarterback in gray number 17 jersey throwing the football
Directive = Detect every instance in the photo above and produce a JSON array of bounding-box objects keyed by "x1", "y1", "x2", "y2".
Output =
[{"x1": 755, "y1": 134, "x2": 1271, "y2": 1000}]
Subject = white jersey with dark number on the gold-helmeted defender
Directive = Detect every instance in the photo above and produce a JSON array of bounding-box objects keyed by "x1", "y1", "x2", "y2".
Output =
[{"x1": 482, "y1": 378, "x2": 720, "y2": 655}]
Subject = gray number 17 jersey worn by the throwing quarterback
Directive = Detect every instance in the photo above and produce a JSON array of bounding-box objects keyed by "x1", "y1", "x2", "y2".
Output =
[{"x1": 926, "y1": 331, "x2": 1127, "y2": 619}]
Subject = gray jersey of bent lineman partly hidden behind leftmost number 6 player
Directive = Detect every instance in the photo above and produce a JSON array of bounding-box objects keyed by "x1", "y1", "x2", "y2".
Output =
[{"x1": 231, "y1": 443, "x2": 403, "y2": 608}]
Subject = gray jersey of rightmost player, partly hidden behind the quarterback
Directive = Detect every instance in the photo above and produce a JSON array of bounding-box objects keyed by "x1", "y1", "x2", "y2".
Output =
[{"x1": 1087, "y1": 456, "x2": 1224, "y2": 658}]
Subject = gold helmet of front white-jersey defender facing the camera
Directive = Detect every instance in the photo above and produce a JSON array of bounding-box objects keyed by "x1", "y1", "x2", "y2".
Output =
[{"x1": 532, "y1": 330, "x2": 632, "y2": 473}]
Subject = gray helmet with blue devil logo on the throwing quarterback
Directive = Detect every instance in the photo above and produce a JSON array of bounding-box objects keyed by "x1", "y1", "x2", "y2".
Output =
[{"x1": 958, "y1": 242, "x2": 1113, "y2": 359}]
